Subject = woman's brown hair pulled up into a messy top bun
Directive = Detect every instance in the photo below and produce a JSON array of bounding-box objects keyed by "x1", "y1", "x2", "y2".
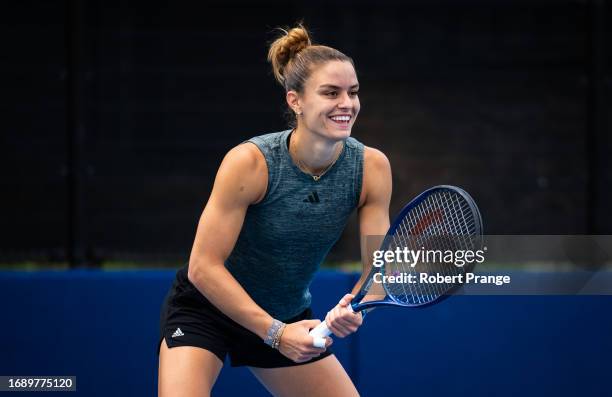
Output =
[{"x1": 268, "y1": 23, "x2": 355, "y2": 126}]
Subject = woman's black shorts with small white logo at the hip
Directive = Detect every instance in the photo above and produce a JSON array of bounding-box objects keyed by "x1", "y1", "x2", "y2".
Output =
[{"x1": 157, "y1": 277, "x2": 332, "y2": 368}]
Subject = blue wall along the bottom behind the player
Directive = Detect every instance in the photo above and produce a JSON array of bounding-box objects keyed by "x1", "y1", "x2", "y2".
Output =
[{"x1": 0, "y1": 271, "x2": 612, "y2": 396}]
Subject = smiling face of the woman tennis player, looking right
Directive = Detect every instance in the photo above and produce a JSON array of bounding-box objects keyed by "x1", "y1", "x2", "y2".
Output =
[{"x1": 287, "y1": 61, "x2": 360, "y2": 141}]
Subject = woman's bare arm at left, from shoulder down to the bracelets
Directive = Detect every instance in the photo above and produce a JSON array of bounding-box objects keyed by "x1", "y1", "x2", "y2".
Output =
[{"x1": 188, "y1": 143, "x2": 273, "y2": 338}]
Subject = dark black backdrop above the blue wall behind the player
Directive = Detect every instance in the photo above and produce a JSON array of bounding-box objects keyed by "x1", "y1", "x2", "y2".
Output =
[{"x1": 0, "y1": 0, "x2": 612, "y2": 264}]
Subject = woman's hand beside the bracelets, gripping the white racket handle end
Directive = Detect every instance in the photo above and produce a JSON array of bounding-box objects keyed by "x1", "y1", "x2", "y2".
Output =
[{"x1": 278, "y1": 320, "x2": 333, "y2": 363}]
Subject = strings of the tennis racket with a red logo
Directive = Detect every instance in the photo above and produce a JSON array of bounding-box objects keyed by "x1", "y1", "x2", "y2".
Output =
[{"x1": 383, "y1": 191, "x2": 479, "y2": 305}]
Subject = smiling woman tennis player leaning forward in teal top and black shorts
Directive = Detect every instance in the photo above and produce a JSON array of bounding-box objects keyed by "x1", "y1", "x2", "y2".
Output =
[{"x1": 158, "y1": 25, "x2": 391, "y2": 397}]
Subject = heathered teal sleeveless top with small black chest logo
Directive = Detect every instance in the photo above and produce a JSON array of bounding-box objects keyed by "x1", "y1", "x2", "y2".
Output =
[{"x1": 182, "y1": 130, "x2": 364, "y2": 320}]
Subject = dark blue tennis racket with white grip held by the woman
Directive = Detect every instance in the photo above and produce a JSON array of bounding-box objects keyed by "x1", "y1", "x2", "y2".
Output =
[{"x1": 310, "y1": 185, "x2": 482, "y2": 347}]
